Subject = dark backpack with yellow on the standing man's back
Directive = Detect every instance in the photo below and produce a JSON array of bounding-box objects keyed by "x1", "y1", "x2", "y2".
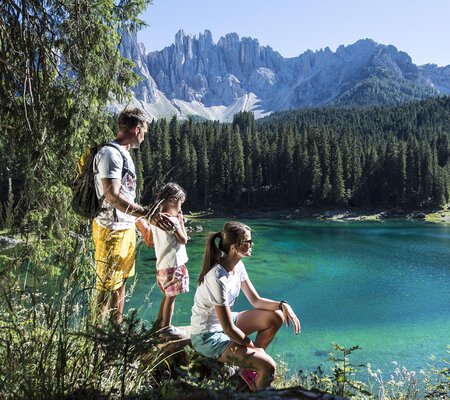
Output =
[{"x1": 71, "y1": 142, "x2": 133, "y2": 219}]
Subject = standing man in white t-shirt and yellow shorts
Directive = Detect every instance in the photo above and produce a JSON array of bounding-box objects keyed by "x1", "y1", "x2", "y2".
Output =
[{"x1": 93, "y1": 108, "x2": 173, "y2": 323}]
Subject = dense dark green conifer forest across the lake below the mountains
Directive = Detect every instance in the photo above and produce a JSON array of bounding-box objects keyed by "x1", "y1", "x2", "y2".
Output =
[{"x1": 135, "y1": 97, "x2": 450, "y2": 209}]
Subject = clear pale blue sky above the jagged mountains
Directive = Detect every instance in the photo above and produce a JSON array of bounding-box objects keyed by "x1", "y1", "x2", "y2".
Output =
[{"x1": 138, "y1": 0, "x2": 450, "y2": 66}]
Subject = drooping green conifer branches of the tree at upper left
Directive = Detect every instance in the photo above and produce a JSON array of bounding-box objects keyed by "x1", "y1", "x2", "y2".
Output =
[{"x1": 0, "y1": 0, "x2": 149, "y2": 236}]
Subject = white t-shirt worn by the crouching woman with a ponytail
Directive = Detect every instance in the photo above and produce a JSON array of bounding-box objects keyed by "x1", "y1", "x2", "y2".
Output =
[{"x1": 191, "y1": 261, "x2": 248, "y2": 334}]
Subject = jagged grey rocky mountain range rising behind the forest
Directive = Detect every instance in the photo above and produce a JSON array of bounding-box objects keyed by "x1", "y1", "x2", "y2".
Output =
[{"x1": 116, "y1": 30, "x2": 450, "y2": 121}]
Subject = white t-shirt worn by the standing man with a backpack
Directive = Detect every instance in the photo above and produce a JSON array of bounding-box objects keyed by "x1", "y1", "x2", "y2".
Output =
[{"x1": 94, "y1": 145, "x2": 136, "y2": 230}]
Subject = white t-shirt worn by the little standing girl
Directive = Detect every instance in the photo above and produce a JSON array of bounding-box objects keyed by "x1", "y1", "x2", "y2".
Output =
[{"x1": 150, "y1": 217, "x2": 188, "y2": 269}]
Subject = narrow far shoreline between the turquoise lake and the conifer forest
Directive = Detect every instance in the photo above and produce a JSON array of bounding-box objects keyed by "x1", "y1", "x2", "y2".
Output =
[{"x1": 187, "y1": 206, "x2": 450, "y2": 223}]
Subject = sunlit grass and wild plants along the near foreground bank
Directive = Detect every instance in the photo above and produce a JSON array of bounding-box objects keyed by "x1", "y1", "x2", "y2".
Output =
[{"x1": 0, "y1": 216, "x2": 450, "y2": 400}]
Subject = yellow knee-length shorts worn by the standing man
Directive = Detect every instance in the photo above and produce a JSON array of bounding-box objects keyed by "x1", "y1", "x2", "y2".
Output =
[{"x1": 92, "y1": 220, "x2": 136, "y2": 291}]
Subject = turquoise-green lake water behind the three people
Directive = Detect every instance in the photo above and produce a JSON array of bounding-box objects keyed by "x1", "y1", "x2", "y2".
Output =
[{"x1": 127, "y1": 219, "x2": 450, "y2": 376}]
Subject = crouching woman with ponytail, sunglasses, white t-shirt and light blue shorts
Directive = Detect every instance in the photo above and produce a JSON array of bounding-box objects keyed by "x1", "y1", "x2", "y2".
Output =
[{"x1": 191, "y1": 222, "x2": 300, "y2": 390}]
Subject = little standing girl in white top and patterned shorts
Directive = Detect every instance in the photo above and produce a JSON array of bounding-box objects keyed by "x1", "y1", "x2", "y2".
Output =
[{"x1": 146, "y1": 182, "x2": 189, "y2": 339}]
